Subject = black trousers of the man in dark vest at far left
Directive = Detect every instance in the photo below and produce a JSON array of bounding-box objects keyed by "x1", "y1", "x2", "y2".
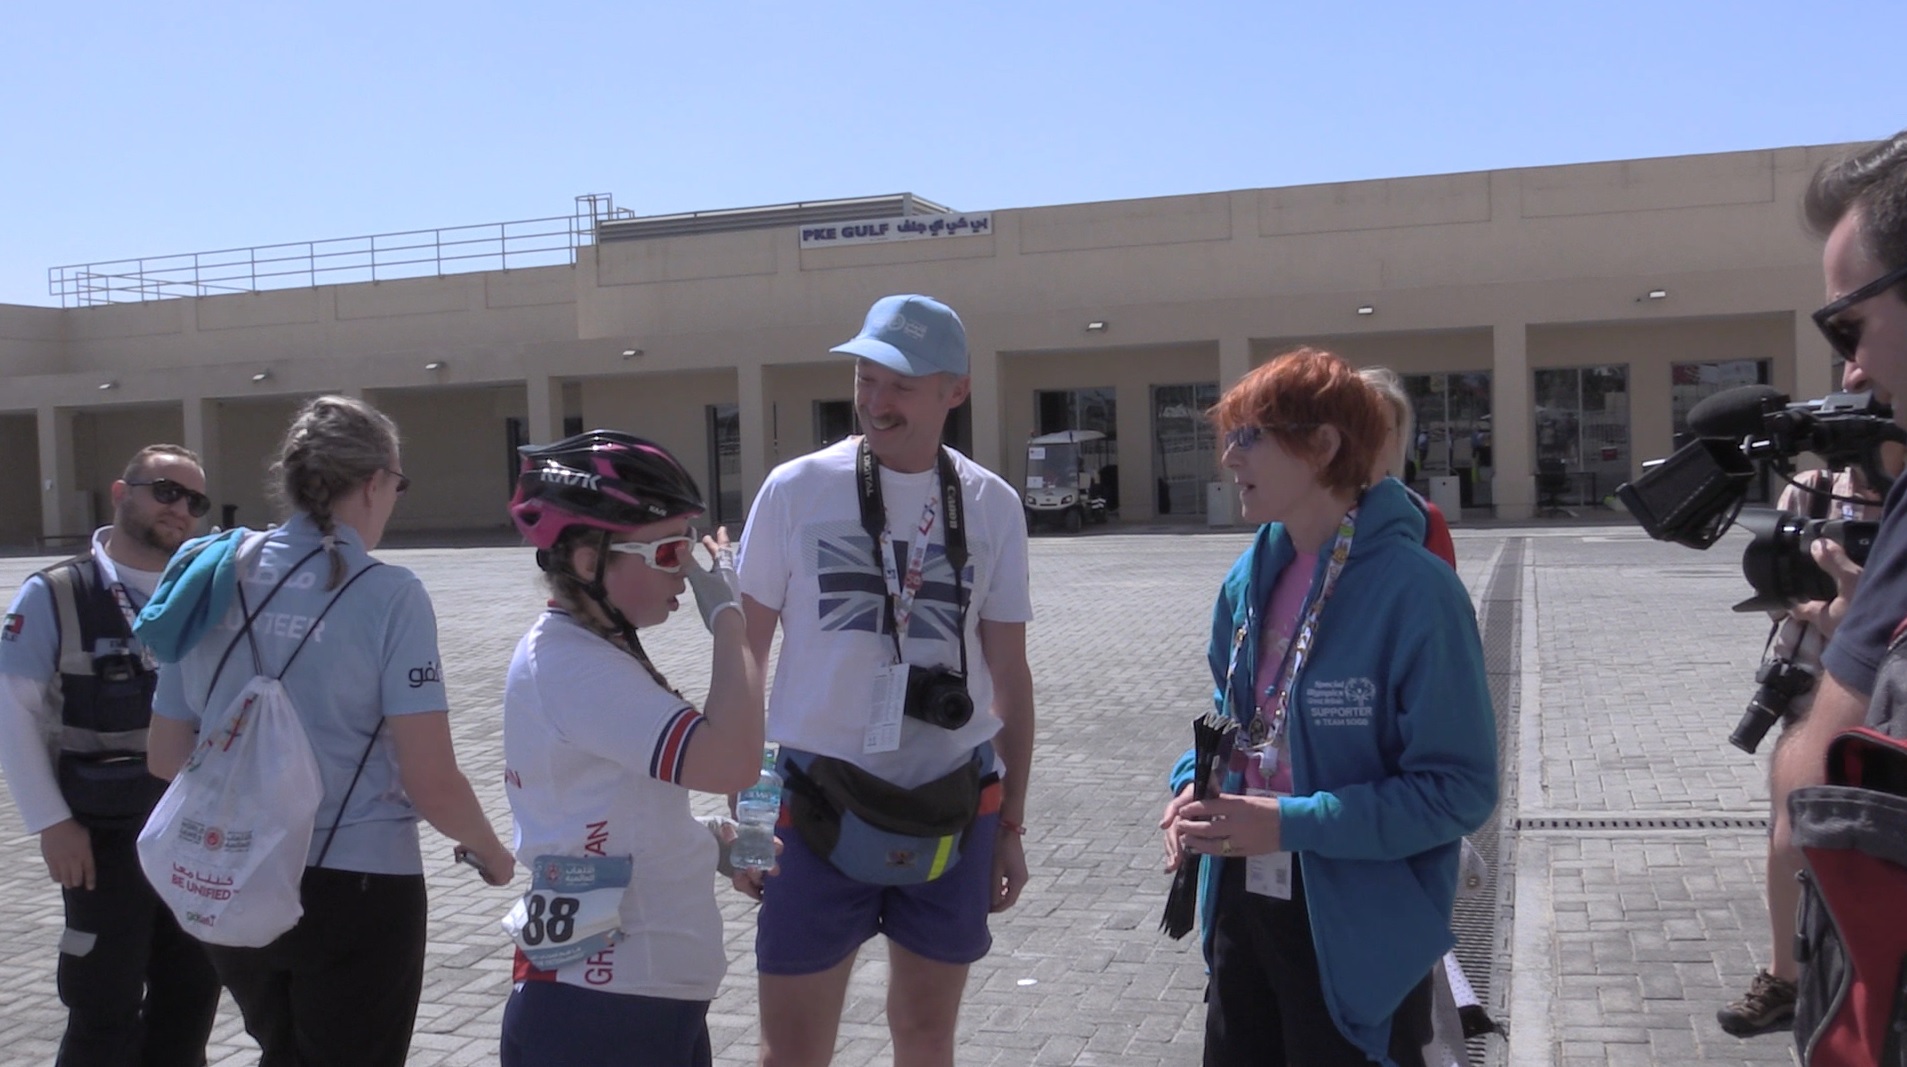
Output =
[{"x1": 57, "y1": 827, "x2": 219, "y2": 1067}]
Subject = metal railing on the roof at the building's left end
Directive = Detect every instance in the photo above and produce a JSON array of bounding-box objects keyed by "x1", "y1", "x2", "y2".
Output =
[{"x1": 46, "y1": 192, "x2": 629, "y2": 307}]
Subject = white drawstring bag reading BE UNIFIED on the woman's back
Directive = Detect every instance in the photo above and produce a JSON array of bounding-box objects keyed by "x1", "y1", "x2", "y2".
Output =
[{"x1": 139, "y1": 674, "x2": 324, "y2": 947}]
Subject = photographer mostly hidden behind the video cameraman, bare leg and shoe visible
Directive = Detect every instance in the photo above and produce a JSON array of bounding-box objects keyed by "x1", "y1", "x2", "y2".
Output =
[{"x1": 1714, "y1": 362, "x2": 1897, "y2": 1037}]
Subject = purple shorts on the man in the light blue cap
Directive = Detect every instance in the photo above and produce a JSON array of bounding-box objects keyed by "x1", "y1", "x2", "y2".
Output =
[{"x1": 755, "y1": 765, "x2": 999, "y2": 976}]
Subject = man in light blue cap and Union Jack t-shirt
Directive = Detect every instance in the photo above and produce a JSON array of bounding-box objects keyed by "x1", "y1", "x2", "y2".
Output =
[{"x1": 736, "y1": 293, "x2": 1034, "y2": 1067}]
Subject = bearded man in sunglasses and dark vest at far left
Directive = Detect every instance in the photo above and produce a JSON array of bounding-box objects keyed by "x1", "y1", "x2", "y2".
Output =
[{"x1": 0, "y1": 444, "x2": 219, "y2": 1067}]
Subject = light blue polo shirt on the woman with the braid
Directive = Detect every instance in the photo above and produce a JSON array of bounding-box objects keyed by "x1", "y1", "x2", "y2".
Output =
[{"x1": 153, "y1": 514, "x2": 450, "y2": 875}]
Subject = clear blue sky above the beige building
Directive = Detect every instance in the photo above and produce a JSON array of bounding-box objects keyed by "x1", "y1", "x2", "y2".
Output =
[{"x1": 0, "y1": 0, "x2": 1907, "y2": 305}]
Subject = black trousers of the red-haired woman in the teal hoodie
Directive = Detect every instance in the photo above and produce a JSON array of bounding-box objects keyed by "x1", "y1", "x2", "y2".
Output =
[{"x1": 1205, "y1": 859, "x2": 1430, "y2": 1067}]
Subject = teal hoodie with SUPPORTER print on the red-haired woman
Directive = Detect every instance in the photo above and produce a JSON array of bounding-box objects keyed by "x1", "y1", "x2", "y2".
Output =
[{"x1": 1171, "y1": 478, "x2": 1497, "y2": 1063}]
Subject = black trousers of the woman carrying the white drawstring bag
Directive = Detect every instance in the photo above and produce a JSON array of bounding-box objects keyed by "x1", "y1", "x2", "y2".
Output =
[{"x1": 208, "y1": 867, "x2": 427, "y2": 1067}]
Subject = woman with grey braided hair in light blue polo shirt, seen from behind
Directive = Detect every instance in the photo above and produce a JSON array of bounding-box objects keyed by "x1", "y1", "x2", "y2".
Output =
[{"x1": 151, "y1": 396, "x2": 515, "y2": 1067}]
